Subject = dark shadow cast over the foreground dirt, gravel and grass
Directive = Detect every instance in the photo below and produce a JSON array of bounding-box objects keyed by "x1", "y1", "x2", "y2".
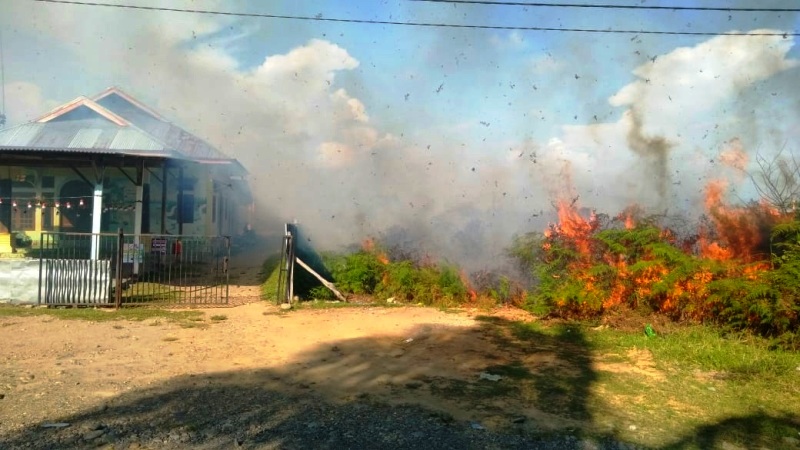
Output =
[{"x1": 0, "y1": 318, "x2": 783, "y2": 449}]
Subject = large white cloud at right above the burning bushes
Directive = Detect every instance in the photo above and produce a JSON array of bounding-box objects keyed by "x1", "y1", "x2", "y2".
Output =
[{"x1": 520, "y1": 30, "x2": 798, "y2": 212}]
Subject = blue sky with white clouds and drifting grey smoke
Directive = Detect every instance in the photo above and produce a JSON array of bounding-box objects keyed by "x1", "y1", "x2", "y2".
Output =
[{"x1": 0, "y1": 0, "x2": 800, "y2": 266}]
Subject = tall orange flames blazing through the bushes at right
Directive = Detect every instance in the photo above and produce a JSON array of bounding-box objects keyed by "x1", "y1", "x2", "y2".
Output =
[{"x1": 542, "y1": 178, "x2": 782, "y2": 320}]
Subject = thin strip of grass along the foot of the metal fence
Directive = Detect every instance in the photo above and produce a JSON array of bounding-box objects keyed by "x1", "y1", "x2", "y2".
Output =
[{"x1": 0, "y1": 305, "x2": 203, "y2": 325}]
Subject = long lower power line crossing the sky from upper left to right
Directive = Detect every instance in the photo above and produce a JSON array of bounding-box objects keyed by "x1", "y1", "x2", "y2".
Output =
[{"x1": 32, "y1": 0, "x2": 800, "y2": 38}]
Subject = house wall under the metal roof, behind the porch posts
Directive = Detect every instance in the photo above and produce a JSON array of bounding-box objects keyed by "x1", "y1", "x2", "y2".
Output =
[{"x1": 0, "y1": 163, "x2": 248, "y2": 253}]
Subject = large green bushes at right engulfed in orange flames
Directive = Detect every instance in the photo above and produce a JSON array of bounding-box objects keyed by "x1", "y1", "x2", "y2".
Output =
[{"x1": 511, "y1": 197, "x2": 800, "y2": 344}]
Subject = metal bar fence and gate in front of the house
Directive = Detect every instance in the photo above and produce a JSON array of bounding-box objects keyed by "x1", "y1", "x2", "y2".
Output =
[{"x1": 38, "y1": 232, "x2": 230, "y2": 306}]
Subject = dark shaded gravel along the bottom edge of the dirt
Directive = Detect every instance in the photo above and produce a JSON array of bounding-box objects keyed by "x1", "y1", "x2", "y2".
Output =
[{"x1": 0, "y1": 379, "x2": 634, "y2": 450}]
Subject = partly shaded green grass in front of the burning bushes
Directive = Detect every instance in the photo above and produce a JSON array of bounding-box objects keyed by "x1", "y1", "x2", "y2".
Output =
[{"x1": 468, "y1": 316, "x2": 800, "y2": 449}]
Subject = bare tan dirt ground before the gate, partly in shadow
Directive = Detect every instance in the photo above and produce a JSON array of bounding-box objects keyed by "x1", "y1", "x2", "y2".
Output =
[{"x1": 0, "y1": 302, "x2": 628, "y2": 448}]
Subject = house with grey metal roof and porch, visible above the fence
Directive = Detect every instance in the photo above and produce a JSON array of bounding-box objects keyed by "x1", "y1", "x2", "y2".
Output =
[{"x1": 0, "y1": 87, "x2": 252, "y2": 256}]
